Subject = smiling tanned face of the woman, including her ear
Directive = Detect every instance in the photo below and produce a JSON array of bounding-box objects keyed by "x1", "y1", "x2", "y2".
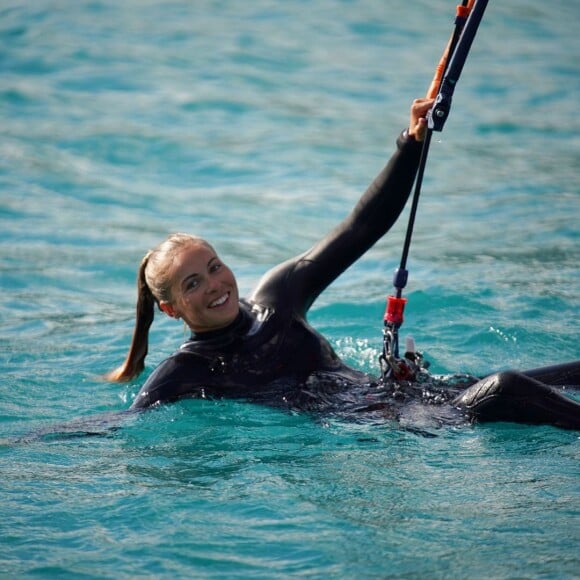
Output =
[{"x1": 160, "y1": 243, "x2": 240, "y2": 332}]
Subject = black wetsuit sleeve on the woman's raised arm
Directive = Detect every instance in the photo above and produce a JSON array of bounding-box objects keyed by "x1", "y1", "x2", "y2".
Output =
[{"x1": 250, "y1": 132, "x2": 421, "y2": 316}]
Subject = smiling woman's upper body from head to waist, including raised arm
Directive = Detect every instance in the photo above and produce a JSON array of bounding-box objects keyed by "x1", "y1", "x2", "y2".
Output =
[{"x1": 107, "y1": 99, "x2": 433, "y2": 407}]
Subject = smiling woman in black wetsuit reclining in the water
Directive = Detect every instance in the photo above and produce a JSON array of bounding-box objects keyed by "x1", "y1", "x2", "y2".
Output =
[{"x1": 108, "y1": 99, "x2": 580, "y2": 428}]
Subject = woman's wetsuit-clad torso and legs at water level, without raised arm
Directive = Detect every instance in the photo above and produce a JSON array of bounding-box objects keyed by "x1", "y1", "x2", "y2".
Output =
[{"x1": 132, "y1": 301, "x2": 580, "y2": 429}]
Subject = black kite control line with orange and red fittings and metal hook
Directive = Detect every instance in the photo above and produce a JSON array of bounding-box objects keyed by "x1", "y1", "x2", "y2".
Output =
[{"x1": 379, "y1": 0, "x2": 487, "y2": 381}]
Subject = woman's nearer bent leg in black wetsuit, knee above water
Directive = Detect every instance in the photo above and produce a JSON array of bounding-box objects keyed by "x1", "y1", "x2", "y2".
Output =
[{"x1": 453, "y1": 369, "x2": 580, "y2": 429}]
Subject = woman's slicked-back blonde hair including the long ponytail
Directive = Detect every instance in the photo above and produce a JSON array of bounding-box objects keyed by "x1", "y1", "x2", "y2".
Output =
[{"x1": 104, "y1": 233, "x2": 213, "y2": 382}]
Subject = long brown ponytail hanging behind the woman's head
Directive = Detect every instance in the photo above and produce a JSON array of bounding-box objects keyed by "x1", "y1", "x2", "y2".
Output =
[{"x1": 104, "y1": 252, "x2": 156, "y2": 382}]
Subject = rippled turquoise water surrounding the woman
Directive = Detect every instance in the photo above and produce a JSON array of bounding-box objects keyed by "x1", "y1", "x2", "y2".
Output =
[{"x1": 0, "y1": 0, "x2": 580, "y2": 578}]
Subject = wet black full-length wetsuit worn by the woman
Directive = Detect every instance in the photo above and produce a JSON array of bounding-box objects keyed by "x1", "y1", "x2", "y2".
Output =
[{"x1": 132, "y1": 134, "x2": 580, "y2": 428}]
